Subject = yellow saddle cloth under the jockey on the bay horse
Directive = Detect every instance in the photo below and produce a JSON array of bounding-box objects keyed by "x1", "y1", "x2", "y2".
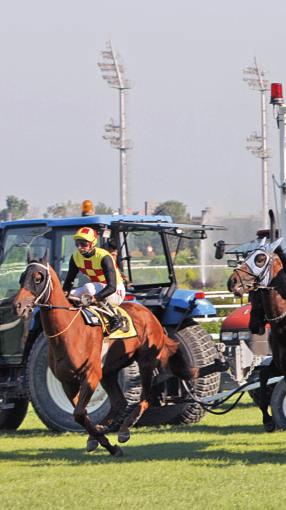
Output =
[{"x1": 81, "y1": 306, "x2": 137, "y2": 340}]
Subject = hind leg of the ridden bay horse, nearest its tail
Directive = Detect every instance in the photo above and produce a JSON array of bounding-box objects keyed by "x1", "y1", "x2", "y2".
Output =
[{"x1": 118, "y1": 360, "x2": 154, "y2": 443}]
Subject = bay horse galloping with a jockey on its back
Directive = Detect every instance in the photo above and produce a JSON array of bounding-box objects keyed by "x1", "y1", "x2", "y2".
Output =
[{"x1": 14, "y1": 256, "x2": 225, "y2": 456}]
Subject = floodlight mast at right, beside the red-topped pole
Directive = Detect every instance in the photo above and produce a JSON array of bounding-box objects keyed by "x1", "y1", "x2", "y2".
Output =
[{"x1": 243, "y1": 58, "x2": 270, "y2": 228}]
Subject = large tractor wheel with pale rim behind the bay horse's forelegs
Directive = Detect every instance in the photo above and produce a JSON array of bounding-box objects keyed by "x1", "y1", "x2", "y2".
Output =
[{"x1": 26, "y1": 333, "x2": 141, "y2": 432}]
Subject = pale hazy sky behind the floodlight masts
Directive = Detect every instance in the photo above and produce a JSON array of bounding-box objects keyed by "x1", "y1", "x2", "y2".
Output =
[{"x1": 0, "y1": 0, "x2": 286, "y2": 219}]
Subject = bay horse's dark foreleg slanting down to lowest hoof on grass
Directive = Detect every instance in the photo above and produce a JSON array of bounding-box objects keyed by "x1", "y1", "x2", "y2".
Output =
[{"x1": 74, "y1": 378, "x2": 122, "y2": 456}]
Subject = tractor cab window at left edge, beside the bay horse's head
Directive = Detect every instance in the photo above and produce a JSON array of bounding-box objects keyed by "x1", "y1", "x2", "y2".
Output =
[{"x1": 0, "y1": 226, "x2": 50, "y2": 301}]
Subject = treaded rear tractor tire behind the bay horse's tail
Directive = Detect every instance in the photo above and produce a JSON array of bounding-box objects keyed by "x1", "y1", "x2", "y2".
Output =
[{"x1": 169, "y1": 325, "x2": 220, "y2": 424}]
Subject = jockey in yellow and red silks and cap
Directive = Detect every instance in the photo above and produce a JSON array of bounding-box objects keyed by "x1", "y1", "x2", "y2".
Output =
[{"x1": 63, "y1": 227, "x2": 125, "y2": 333}]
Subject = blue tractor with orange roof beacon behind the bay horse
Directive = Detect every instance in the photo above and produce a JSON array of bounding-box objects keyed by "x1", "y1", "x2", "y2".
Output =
[{"x1": 0, "y1": 215, "x2": 223, "y2": 431}]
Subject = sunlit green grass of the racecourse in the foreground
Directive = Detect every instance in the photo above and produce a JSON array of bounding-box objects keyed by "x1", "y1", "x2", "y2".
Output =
[{"x1": 0, "y1": 398, "x2": 286, "y2": 510}]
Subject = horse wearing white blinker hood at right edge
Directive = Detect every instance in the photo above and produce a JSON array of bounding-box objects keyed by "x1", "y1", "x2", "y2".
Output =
[{"x1": 228, "y1": 238, "x2": 286, "y2": 432}]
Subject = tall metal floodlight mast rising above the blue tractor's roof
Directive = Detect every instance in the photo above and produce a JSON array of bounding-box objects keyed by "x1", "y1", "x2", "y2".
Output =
[{"x1": 98, "y1": 41, "x2": 132, "y2": 214}]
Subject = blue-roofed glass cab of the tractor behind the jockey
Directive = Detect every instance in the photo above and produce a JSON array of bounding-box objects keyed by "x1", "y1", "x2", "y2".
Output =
[{"x1": 0, "y1": 215, "x2": 223, "y2": 366}]
